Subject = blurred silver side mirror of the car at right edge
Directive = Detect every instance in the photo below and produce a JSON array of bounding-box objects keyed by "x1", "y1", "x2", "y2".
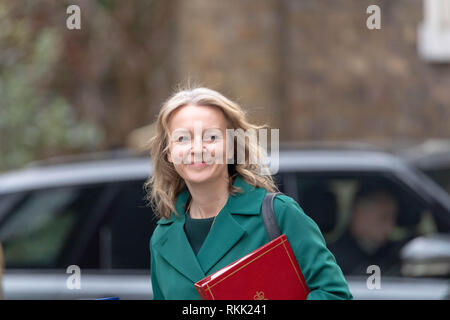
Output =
[{"x1": 400, "y1": 234, "x2": 450, "y2": 277}]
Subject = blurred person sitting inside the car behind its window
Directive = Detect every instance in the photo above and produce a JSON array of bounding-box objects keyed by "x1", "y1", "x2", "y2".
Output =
[{"x1": 329, "y1": 185, "x2": 399, "y2": 274}]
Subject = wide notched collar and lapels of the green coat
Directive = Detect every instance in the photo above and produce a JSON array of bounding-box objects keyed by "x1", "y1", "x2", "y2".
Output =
[{"x1": 155, "y1": 176, "x2": 266, "y2": 282}]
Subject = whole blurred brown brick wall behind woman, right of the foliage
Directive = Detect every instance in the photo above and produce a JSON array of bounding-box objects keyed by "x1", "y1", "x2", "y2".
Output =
[{"x1": 176, "y1": 0, "x2": 450, "y2": 143}]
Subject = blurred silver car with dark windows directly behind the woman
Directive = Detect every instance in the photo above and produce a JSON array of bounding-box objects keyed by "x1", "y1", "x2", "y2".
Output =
[{"x1": 0, "y1": 149, "x2": 450, "y2": 299}]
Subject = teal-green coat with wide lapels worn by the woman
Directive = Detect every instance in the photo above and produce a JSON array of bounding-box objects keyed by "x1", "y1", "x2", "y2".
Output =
[{"x1": 150, "y1": 176, "x2": 352, "y2": 300}]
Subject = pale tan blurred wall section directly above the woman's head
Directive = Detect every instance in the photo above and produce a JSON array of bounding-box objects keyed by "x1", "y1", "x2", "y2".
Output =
[{"x1": 176, "y1": 0, "x2": 281, "y2": 134}]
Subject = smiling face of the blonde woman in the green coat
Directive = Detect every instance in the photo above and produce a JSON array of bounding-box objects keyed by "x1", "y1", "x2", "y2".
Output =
[{"x1": 168, "y1": 105, "x2": 228, "y2": 184}]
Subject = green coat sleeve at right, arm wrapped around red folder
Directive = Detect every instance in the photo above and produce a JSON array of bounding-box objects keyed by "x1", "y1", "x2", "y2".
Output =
[{"x1": 274, "y1": 195, "x2": 353, "y2": 300}]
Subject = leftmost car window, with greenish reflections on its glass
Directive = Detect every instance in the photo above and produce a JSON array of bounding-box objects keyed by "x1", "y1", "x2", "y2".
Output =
[{"x1": 0, "y1": 186, "x2": 102, "y2": 268}]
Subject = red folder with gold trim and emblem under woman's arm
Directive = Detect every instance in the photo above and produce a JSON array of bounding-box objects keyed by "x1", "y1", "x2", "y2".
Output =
[{"x1": 195, "y1": 234, "x2": 309, "y2": 300}]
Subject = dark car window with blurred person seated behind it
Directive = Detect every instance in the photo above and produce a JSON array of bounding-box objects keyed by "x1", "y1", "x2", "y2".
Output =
[{"x1": 286, "y1": 173, "x2": 436, "y2": 276}]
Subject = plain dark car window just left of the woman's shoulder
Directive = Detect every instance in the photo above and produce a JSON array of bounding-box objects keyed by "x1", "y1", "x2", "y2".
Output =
[{"x1": 95, "y1": 180, "x2": 157, "y2": 270}]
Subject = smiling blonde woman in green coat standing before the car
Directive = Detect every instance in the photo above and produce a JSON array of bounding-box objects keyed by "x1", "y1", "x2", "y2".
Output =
[{"x1": 146, "y1": 88, "x2": 352, "y2": 299}]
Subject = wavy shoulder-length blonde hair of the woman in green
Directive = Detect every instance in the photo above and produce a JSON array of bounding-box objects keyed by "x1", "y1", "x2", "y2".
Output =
[{"x1": 144, "y1": 87, "x2": 278, "y2": 219}]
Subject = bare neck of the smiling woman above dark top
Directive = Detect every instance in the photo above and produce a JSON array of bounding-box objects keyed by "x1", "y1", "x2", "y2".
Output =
[{"x1": 186, "y1": 177, "x2": 229, "y2": 219}]
